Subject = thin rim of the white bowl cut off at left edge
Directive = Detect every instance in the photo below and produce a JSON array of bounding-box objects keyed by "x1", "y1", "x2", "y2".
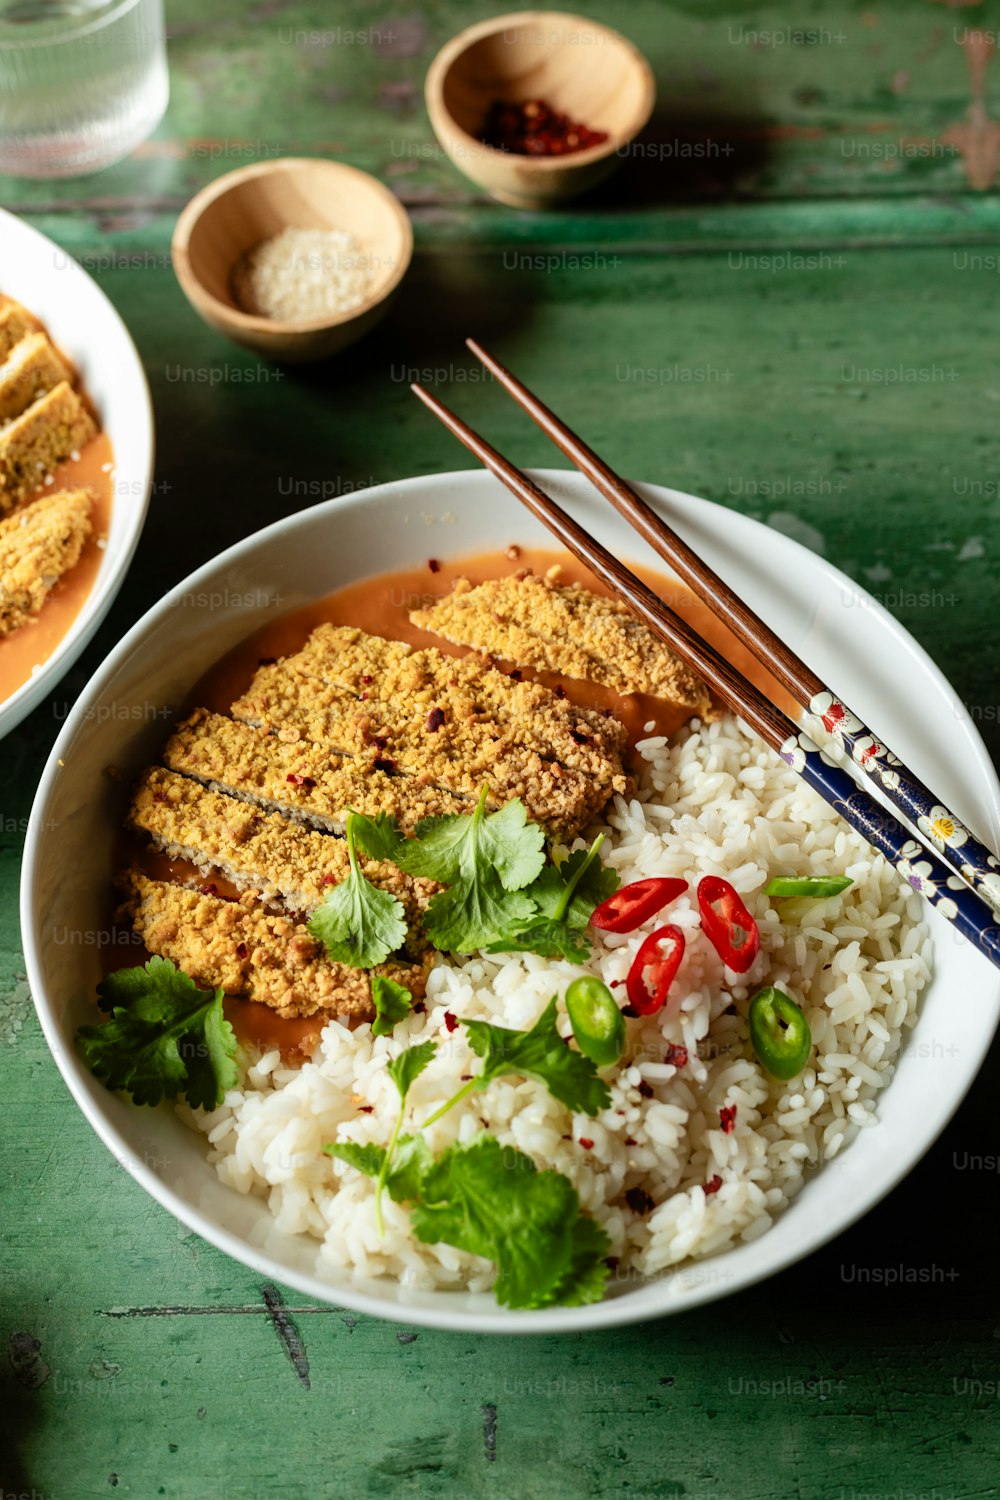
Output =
[{"x1": 0, "y1": 209, "x2": 156, "y2": 740}]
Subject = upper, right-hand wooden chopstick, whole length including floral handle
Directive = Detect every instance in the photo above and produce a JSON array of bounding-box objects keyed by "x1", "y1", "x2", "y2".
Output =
[{"x1": 465, "y1": 339, "x2": 1000, "y2": 914}]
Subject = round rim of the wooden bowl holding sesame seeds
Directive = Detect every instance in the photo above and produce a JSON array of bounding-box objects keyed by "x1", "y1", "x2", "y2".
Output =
[{"x1": 171, "y1": 156, "x2": 414, "y2": 338}]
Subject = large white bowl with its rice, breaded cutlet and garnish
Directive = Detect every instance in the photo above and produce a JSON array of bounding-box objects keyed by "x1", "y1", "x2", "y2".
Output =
[{"x1": 22, "y1": 473, "x2": 1000, "y2": 1332}]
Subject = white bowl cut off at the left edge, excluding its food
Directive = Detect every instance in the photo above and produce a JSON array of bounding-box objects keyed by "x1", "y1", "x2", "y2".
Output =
[{"x1": 0, "y1": 209, "x2": 153, "y2": 738}]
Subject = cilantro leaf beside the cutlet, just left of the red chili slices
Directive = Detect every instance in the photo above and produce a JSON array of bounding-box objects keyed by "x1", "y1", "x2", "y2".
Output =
[{"x1": 487, "y1": 834, "x2": 619, "y2": 963}]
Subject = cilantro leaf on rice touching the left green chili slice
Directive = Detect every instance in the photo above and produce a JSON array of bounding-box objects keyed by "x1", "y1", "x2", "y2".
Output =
[{"x1": 462, "y1": 998, "x2": 612, "y2": 1115}]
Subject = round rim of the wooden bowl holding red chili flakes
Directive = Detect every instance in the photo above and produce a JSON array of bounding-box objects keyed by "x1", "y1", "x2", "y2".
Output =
[{"x1": 424, "y1": 11, "x2": 657, "y2": 176}]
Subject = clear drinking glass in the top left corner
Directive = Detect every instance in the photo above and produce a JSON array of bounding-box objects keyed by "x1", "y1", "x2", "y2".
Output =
[{"x1": 0, "y1": 0, "x2": 168, "y2": 177}]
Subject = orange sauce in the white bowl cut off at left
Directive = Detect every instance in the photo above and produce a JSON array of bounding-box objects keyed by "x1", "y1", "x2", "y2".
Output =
[{"x1": 0, "y1": 296, "x2": 114, "y2": 702}]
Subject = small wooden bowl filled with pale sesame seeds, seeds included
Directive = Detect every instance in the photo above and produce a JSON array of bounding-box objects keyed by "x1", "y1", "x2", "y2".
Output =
[{"x1": 171, "y1": 158, "x2": 414, "y2": 363}]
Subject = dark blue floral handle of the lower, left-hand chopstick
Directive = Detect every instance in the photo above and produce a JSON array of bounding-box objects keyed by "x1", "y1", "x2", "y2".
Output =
[{"x1": 778, "y1": 734, "x2": 1000, "y2": 968}]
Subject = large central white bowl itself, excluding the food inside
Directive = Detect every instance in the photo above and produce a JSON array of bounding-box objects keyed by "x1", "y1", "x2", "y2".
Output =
[{"x1": 21, "y1": 470, "x2": 1000, "y2": 1334}]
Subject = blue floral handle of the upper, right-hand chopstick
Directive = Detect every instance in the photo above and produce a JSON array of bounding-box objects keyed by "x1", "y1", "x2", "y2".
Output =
[{"x1": 808, "y1": 692, "x2": 1000, "y2": 915}]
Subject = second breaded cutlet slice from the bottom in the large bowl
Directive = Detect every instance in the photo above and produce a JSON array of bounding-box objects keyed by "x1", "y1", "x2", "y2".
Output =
[{"x1": 126, "y1": 767, "x2": 438, "y2": 953}]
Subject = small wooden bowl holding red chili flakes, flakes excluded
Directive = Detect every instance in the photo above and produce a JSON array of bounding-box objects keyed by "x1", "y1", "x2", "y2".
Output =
[{"x1": 424, "y1": 11, "x2": 657, "y2": 209}]
